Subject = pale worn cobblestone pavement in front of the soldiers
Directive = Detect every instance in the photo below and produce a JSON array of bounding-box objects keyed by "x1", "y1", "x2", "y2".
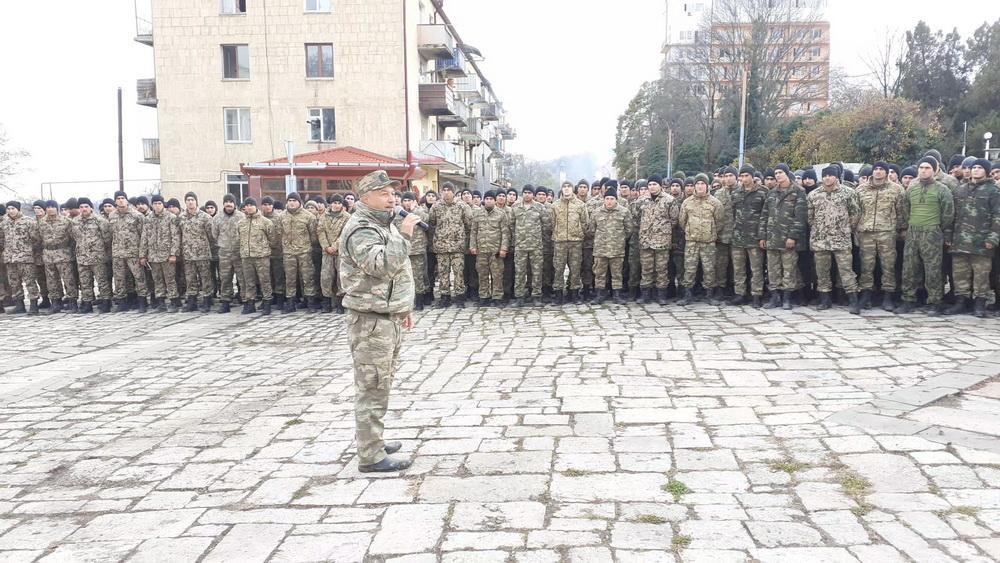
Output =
[{"x1": 0, "y1": 304, "x2": 1000, "y2": 563}]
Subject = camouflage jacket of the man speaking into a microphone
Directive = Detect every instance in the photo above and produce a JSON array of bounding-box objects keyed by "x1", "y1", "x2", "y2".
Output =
[{"x1": 339, "y1": 202, "x2": 419, "y2": 316}]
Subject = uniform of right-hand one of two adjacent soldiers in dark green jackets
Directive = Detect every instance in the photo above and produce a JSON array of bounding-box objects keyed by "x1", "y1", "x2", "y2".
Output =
[{"x1": 757, "y1": 184, "x2": 809, "y2": 292}]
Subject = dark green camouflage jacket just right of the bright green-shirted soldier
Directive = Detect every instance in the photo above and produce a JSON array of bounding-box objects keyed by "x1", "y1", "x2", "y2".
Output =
[{"x1": 946, "y1": 179, "x2": 1000, "y2": 256}]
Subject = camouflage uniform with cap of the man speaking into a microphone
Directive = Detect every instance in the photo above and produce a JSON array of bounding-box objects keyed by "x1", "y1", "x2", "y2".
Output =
[{"x1": 340, "y1": 194, "x2": 412, "y2": 465}]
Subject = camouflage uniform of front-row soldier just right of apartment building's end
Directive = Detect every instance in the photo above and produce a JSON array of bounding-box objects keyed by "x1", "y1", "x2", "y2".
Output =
[{"x1": 511, "y1": 201, "x2": 552, "y2": 299}]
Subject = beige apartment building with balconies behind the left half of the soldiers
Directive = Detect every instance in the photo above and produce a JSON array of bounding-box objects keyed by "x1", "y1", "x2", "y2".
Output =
[{"x1": 136, "y1": 0, "x2": 515, "y2": 203}]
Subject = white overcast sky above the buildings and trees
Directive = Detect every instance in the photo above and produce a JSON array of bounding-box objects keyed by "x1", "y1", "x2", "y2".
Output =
[{"x1": 0, "y1": 0, "x2": 988, "y2": 200}]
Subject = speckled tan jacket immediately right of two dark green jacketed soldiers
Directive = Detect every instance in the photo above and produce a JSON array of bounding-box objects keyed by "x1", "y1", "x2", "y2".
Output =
[{"x1": 806, "y1": 185, "x2": 861, "y2": 250}]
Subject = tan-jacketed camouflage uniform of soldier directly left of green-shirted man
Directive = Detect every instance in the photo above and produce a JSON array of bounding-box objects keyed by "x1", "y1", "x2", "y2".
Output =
[{"x1": 857, "y1": 179, "x2": 905, "y2": 293}]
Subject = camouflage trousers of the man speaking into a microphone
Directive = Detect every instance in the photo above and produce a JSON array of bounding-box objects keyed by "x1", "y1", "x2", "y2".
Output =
[{"x1": 347, "y1": 308, "x2": 404, "y2": 465}]
